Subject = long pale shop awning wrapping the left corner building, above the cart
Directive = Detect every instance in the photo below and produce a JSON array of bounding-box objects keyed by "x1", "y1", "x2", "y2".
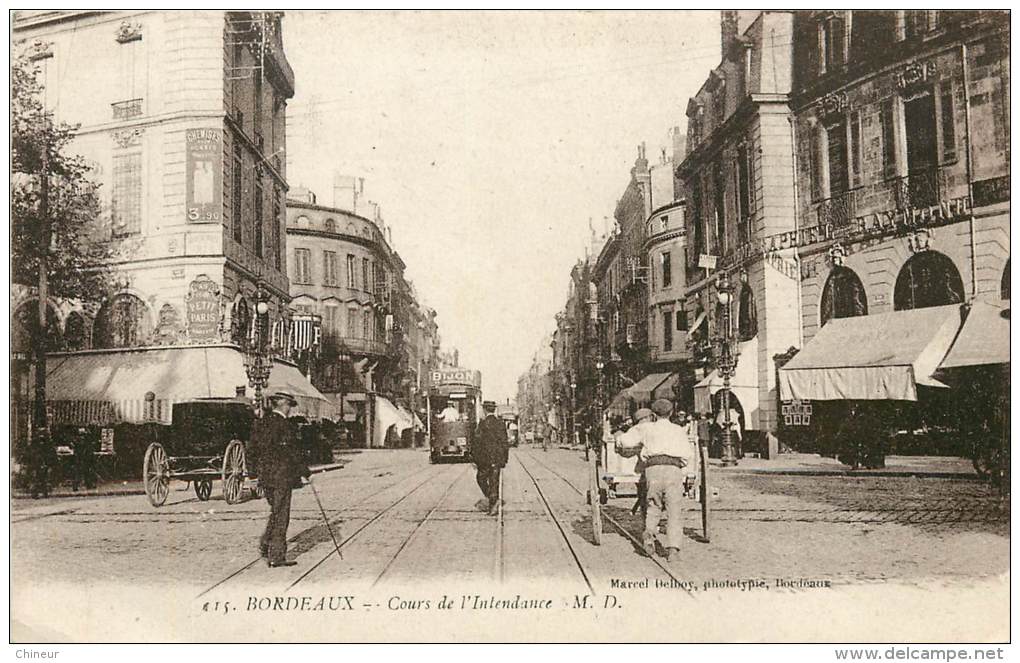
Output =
[{"x1": 37, "y1": 346, "x2": 332, "y2": 424}]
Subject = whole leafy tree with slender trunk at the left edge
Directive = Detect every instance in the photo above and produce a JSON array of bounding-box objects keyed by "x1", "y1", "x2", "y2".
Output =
[{"x1": 10, "y1": 54, "x2": 112, "y2": 495}]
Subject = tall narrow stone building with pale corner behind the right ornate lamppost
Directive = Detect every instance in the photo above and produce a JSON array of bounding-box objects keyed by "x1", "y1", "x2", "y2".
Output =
[{"x1": 677, "y1": 11, "x2": 800, "y2": 431}]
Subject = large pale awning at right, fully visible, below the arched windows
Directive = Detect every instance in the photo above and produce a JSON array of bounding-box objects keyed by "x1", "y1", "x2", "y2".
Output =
[{"x1": 779, "y1": 304, "x2": 960, "y2": 401}]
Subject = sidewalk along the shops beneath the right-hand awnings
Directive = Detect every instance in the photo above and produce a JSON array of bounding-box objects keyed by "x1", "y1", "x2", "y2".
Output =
[{"x1": 709, "y1": 453, "x2": 977, "y2": 478}]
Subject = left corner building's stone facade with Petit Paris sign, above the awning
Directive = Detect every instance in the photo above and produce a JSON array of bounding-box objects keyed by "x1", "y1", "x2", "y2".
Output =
[{"x1": 12, "y1": 11, "x2": 294, "y2": 350}]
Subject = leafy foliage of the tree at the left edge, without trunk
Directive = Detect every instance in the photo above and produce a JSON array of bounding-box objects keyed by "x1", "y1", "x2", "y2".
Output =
[{"x1": 10, "y1": 55, "x2": 113, "y2": 301}]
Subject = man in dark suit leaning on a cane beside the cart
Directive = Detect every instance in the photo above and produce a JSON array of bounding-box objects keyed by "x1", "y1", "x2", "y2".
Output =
[{"x1": 251, "y1": 392, "x2": 311, "y2": 567}]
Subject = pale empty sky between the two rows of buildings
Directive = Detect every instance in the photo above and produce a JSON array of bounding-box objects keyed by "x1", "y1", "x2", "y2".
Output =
[{"x1": 284, "y1": 11, "x2": 719, "y2": 400}]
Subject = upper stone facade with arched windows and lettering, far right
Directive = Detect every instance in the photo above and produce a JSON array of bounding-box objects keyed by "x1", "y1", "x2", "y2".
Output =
[{"x1": 789, "y1": 10, "x2": 1010, "y2": 343}]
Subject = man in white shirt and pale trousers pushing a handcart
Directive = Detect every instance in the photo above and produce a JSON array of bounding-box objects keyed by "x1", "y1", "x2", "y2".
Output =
[{"x1": 621, "y1": 399, "x2": 698, "y2": 564}]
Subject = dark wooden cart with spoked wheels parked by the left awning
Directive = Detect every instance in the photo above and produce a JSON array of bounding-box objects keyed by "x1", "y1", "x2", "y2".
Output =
[{"x1": 142, "y1": 399, "x2": 255, "y2": 507}]
